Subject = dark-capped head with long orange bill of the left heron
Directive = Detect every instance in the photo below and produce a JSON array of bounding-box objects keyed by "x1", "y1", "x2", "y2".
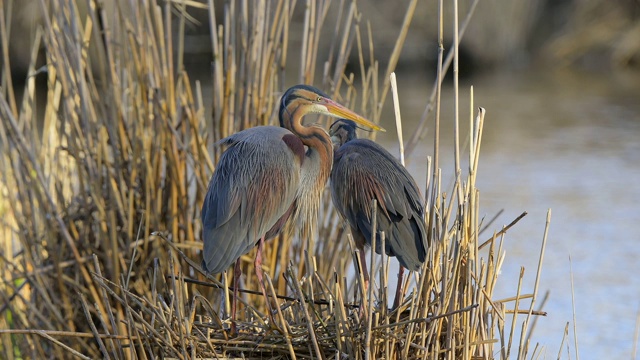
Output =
[{"x1": 280, "y1": 85, "x2": 385, "y2": 131}]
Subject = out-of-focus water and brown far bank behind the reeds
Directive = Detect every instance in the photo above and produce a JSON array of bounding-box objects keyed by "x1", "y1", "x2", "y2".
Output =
[{"x1": 3, "y1": 0, "x2": 640, "y2": 359}]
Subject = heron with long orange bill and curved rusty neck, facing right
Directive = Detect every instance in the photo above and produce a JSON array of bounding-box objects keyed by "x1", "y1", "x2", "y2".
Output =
[{"x1": 202, "y1": 85, "x2": 383, "y2": 329}]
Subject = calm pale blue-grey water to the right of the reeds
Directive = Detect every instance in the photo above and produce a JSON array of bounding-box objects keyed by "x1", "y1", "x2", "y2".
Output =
[{"x1": 378, "y1": 72, "x2": 640, "y2": 359}]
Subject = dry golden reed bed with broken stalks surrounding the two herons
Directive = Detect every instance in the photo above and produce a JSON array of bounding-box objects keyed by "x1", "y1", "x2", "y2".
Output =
[{"x1": 0, "y1": 0, "x2": 548, "y2": 359}]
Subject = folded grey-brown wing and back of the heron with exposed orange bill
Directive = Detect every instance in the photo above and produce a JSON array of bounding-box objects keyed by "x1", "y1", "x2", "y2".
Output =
[{"x1": 202, "y1": 126, "x2": 302, "y2": 273}]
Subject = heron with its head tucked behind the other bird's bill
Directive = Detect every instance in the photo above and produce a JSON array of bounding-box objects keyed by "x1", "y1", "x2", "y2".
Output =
[{"x1": 329, "y1": 119, "x2": 428, "y2": 308}]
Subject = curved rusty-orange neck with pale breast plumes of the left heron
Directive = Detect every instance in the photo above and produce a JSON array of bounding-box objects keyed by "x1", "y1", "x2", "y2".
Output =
[{"x1": 280, "y1": 107, "x2": 333, "y2": 237}]
